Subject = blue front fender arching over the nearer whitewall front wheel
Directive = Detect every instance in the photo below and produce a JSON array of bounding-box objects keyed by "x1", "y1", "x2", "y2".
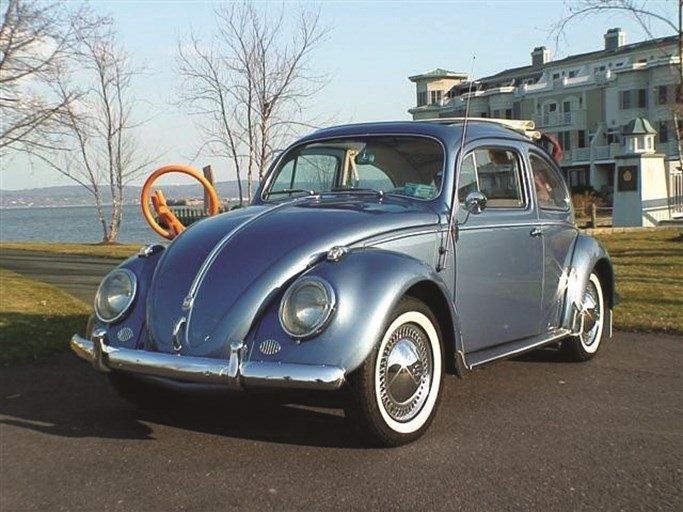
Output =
[{"x1": 247, "y1": 249, "x2": 457, "y2": 375}]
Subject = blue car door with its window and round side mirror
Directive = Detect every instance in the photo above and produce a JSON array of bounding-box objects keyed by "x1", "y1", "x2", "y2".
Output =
[{"x1": 455, "y1": 143, "x2": 543, "y2": 353}]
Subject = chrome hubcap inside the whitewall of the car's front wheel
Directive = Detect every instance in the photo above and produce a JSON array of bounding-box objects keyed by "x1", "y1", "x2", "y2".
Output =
[{"x1": 379, "y1": 324, "x2": 432, "y2": 421}]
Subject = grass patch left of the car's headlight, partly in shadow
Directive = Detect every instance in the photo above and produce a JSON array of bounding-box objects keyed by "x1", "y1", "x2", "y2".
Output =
[{"x1": 0, "y1": 268, "x2": 90, "y2": 365}]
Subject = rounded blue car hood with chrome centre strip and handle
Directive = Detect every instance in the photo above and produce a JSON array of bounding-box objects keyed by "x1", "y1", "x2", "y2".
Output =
[{"x1": 147, "y1": 196, "x2": 439, "y2": 357}]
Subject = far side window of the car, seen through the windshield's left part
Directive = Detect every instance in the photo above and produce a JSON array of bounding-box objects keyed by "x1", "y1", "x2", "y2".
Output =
[{"x1": 271, "y1": 154, "x2": 338, "y2": 192}]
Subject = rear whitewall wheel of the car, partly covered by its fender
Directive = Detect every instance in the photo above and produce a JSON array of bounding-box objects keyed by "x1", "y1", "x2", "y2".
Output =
[{"x1": 561, "y1": 272, "x2": 605, "y2": 361}]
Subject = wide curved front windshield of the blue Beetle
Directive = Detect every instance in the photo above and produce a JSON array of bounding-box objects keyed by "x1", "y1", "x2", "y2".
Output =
[{"x1": 263, "y1": 136, "x2": 444, "y2": 202}]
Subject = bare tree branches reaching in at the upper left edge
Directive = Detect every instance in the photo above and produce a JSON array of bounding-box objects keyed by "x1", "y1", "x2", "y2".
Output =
[{"x1": 0, "y1": 0, "x2": 92, "y2": 154}]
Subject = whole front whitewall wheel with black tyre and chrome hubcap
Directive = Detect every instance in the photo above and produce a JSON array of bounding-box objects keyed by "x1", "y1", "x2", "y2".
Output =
[{"x1": 346, "y1": 297, "x2": 443, "y2": 446}]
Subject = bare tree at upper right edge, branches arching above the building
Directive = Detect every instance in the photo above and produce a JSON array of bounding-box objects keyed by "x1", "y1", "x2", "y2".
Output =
[{"x1": 551, "y1": 0, "x2": 683, "y2": 169}]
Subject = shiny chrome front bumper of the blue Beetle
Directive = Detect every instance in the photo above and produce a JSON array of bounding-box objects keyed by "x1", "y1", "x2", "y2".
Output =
[{"x1": 71, "y1": 331, "x2": 344, "y2": 391}]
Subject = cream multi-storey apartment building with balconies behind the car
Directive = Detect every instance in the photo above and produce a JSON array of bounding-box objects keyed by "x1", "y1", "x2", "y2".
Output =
[{"x1": 408, "y1": 28, "x2": 681, "y2": 201}]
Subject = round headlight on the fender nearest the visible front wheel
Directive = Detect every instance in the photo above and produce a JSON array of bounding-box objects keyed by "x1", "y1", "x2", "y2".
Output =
[{"x1": 280, "y1": 277, "x2": 335, "y2": 338}]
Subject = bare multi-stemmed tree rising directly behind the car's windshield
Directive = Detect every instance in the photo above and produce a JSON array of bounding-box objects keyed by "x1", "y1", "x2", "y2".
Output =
[{"x1": 178, "y1": 1, "x2": 327, "y2": 206}]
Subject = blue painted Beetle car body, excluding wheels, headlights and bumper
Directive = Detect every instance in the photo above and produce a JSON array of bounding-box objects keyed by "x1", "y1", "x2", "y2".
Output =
[{"x1": 77, "y1": 118, "x2": 614, "y2": 386}]
